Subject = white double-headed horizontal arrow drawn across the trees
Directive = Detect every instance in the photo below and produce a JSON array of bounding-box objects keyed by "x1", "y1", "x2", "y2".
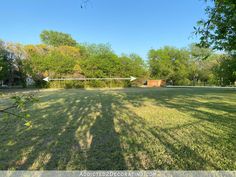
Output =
[{"x1": 43, "y1": 76, "x2": 137, "y2": 82}]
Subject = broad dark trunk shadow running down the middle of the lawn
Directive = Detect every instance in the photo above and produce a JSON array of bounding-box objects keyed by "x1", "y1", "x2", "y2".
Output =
[{"x1": 87, "y1": 94, "x2": 127, "y2": 170}]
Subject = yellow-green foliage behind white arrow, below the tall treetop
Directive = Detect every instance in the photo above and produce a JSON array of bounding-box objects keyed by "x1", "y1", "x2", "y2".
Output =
[{"x1": 21, "y1": 41, "x2": 147, "y2": 88}]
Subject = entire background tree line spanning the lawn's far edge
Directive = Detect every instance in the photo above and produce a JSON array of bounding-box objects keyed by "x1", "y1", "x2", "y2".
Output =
[{"x1": 0, "y1": 30, "x2": 236, "y2": 88}]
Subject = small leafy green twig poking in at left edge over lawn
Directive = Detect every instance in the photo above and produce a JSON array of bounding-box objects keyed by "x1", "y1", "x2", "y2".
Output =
[{"x1": 0, "y1": 94, "x2": 38, "y2": 127}]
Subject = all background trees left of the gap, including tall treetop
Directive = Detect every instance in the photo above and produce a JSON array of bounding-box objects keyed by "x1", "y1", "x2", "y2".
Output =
[{"x1": 0, "y1": 31, "x2": 148, "y2": 87}]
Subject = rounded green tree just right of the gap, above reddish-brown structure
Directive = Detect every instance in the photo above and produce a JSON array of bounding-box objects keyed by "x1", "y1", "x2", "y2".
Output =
[{"x1": 148, "y1": 46, "x2": 189, "y2": 85}]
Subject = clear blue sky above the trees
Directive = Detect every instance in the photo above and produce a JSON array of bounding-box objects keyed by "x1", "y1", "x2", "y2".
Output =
[{"x1": 0, "y1": 0, "x2": 206, "y2": 59}]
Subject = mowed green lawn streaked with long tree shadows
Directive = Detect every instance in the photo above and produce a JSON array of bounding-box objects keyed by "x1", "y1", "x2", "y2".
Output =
[{"x1": 0, "y1": 88, "x2": 236, "y2": 170}]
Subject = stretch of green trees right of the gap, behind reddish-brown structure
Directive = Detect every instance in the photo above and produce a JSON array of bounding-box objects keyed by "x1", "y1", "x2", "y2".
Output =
[{"x1": 148, "y1": 44, "x2": 236, "y2": 85}]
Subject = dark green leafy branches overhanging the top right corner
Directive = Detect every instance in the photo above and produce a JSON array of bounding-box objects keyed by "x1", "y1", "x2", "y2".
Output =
[{"x1": 194, "y1": 0, "x2": 236, "y2": 53}]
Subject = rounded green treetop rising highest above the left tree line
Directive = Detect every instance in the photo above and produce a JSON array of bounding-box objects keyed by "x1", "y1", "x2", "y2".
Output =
[{"x1": 40, "y1": 30, "x2": 77, "y2": 47}]
